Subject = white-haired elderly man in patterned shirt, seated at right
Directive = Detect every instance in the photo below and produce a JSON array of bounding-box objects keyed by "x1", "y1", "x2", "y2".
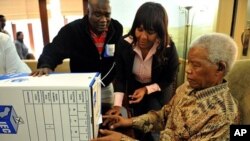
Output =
[{"x1": 93, "y1": 33, "x2": 239, "y2": 141}]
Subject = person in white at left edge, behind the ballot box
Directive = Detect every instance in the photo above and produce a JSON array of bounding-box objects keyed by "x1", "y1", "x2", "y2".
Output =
[{"x1": 0, "y1": 32, "x2": 31, "y2": 74}]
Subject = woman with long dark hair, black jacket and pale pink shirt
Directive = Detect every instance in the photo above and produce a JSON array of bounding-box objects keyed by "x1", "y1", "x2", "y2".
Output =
[{"x1": 107, "y1": 2, "x2": 179, "y2": 141}]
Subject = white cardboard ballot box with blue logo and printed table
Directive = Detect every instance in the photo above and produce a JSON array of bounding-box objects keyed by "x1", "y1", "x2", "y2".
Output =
[{"x1": 0, "y1": 73, "x2": 102, "y2": 141}]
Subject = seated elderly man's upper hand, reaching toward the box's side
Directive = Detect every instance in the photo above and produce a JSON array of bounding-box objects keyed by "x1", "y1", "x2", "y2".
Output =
[{"x1": 102, "y1": 115, "x2": 132, "y2": 130}]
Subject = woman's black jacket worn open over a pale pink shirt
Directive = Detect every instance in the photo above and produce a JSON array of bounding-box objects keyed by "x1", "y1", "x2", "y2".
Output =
[{"x1": 114, "y1": 37, "x2": 179, "y2": 94}]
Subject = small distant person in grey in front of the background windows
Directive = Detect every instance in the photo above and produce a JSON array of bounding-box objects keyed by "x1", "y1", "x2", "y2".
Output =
[{"x1": 15, "y1": 31, "x2": 29, "y2": 59}]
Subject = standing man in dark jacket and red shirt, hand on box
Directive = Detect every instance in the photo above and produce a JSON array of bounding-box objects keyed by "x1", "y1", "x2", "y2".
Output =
[{"x1": 31, "y1": 0, "x2": 123, "y2": 112}]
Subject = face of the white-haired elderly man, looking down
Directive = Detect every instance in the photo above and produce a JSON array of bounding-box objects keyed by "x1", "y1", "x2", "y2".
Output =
[{"x1": 186, "y1": 46, "x2": 221, "y2": 89}]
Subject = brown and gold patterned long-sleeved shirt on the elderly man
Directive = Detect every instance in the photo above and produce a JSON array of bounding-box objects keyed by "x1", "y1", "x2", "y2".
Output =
[{"x1": 123, "y1": 82, "x2": 239, "y2": 141}]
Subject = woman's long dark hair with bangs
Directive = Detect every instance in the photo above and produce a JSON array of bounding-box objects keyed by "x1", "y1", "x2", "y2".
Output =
[{"x1": 128, "y1": 2, "x2": 170, "y2": 63}]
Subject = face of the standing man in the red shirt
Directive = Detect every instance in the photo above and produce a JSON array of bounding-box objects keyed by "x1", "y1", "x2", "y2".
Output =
[{"x1": 88, "y1": 2, "x2": 111, "y2": 34}]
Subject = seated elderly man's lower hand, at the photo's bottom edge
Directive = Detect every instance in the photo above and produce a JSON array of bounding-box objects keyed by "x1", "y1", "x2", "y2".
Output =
[{"x1": 91, "y1": 129, "x2": 122, "y2": 141}]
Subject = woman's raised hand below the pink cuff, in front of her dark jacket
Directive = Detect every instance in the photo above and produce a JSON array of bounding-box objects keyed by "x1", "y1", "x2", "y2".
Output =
[{"x1": 129, "y1": 87, "x2": 147, "y2": 104}]
